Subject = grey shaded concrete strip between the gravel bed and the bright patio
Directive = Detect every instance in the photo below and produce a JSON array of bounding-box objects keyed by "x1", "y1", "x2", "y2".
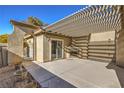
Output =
[{"x1": 23, "y1": 62, "x2": 76, "y2": 88}]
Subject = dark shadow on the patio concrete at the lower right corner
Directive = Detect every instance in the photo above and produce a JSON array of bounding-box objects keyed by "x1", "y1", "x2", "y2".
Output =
[{"x1": 106, "y1": 62, "x2": 124, "y2": 88}]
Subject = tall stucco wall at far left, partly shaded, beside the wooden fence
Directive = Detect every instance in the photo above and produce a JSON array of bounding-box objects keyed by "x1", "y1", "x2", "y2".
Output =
[{"x1": 8, "y1": 27, "x2": 25, "y2": 64}]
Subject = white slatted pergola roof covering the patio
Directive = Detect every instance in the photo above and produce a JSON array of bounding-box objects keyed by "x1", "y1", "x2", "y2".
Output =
[{"x1": 44, "y1": 5, "x2": 121, "y2": 37}]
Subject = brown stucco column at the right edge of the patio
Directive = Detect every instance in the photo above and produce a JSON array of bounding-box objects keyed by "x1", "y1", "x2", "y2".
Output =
[{"x1": 116, "y1": 6, "x2": 124, "y2": 67}]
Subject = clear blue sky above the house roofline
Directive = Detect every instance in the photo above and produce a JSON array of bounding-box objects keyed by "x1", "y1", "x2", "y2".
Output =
[{"x1": 0, "y1": 5, "x2": 86, "y2": 34}]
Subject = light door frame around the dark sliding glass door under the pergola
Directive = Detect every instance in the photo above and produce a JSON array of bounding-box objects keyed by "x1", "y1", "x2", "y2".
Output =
[{"x1": 49, "y1": 38, "x2": 64, "y2": 60}]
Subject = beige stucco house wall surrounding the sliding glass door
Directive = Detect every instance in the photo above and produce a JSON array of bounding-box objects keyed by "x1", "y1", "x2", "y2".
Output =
[{"x1": 24, "y1": 34, "x2": 71, "y2": 62}]
